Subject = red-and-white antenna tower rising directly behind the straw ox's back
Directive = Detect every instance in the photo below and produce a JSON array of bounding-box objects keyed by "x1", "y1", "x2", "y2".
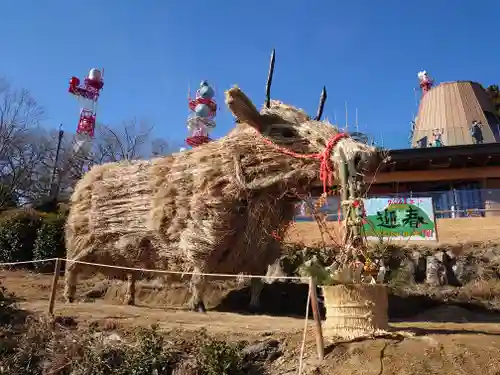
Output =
[{"x1": 186, "y1": 81, "x2": 217, "y2": 147}]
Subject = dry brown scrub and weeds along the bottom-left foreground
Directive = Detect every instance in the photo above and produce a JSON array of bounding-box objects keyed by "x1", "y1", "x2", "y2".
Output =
[{"x1": 0, "y1": 316, "x2": 263, "y2": 375}]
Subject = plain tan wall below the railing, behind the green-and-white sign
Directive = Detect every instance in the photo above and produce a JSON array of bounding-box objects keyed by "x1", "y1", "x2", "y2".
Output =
[{"x1": 286, "y1": 216, "x2": 500, "y2": 245}]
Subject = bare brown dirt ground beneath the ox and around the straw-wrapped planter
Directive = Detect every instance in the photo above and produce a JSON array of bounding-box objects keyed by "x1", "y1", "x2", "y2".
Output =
[{"x1": 0, "y1": 271, "x2": 500, "y2": 375}]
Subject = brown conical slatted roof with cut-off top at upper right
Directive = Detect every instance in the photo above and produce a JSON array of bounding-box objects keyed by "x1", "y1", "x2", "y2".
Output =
[{"x1": 412, "y1": 81, "x2": 500, "y2": 147}]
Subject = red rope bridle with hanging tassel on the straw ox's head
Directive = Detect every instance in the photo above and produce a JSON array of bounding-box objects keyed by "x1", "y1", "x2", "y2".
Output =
[{"x1": 263, "y1": 133, "x2": 349, "y2": 193}]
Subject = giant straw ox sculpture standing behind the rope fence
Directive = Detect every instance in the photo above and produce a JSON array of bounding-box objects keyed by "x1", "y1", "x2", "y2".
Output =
[{"x1": 65, "y1": 88, "x2": 378, "y2": 311}]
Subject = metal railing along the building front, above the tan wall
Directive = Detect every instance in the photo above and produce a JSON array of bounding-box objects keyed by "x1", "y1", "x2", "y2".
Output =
[{"x1": 295, "y1": 189, "x2": 500, "y2": 221}]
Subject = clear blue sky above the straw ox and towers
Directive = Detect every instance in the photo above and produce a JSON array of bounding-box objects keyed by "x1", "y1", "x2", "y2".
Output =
[{"x1": 0, "y1": 0, "x2": 500, "y2": 148}]
